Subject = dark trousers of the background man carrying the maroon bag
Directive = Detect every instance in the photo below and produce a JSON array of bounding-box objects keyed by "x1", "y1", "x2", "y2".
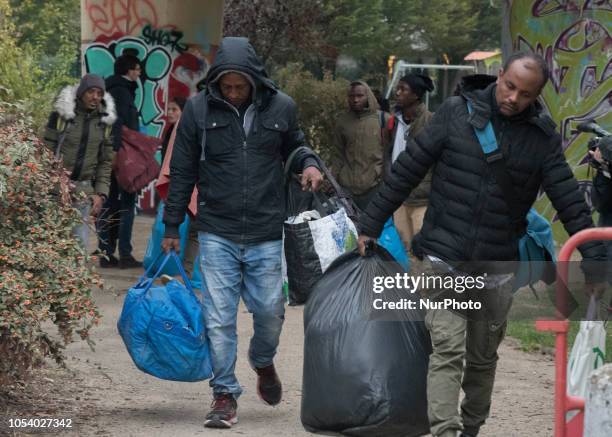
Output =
[{"x1": 96, "y1": 174, "x2": 137, "y2": 257}]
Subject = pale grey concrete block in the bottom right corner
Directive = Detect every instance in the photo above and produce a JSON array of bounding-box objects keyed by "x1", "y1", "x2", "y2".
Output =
[{"x1": 583, "y1": 364, "x2": 612, "y2": 437}]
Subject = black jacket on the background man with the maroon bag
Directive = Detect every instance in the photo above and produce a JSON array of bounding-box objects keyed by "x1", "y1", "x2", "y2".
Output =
[{"x1": 106, "y1": 74, "x2": 139, "y2": 150}]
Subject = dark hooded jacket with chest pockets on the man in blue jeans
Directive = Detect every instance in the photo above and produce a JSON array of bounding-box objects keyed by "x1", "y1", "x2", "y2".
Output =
[{"x1": 164, "y1": 38, "x2": 316, "y2": 243}]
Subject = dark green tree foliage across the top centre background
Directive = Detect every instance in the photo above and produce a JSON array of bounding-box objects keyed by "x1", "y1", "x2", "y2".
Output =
[{"x1": 224, "y1": 0, "x2": 502, "y2": 79}]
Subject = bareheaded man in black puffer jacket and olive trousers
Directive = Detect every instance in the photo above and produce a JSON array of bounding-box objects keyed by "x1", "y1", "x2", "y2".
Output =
[{"x1": 359, "y1": 53, "x2": 606, "y2": 437}]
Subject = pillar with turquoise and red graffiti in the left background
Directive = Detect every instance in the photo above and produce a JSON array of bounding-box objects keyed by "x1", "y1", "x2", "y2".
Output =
[{"x1": 81, "y1": 0, "x2": 223, "y2": 209}]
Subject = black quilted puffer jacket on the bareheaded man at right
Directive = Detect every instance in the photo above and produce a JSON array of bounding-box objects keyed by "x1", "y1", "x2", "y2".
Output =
[{"x1": 361, "y1": 76, "x2": 605, "y2": 278}]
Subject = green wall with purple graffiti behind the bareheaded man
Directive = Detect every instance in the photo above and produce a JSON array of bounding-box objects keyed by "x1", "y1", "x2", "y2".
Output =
[{"x1": 506, "y1": 0, "x2": 612, "y2": 242}]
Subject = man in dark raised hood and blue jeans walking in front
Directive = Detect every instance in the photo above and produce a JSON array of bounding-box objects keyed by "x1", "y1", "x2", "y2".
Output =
[{"x1": 162, "y1": 37, "x2": 322, "y2": 428}]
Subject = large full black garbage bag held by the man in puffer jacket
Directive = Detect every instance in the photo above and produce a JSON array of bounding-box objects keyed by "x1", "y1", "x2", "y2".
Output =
[{"x1": 301, "y1": 246, "x2": 431, "y2": 437}]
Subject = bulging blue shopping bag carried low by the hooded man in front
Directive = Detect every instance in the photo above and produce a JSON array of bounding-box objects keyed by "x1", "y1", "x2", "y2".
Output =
[{"x1": 117, "y1": 251, "x2": 212, "y2": 382}]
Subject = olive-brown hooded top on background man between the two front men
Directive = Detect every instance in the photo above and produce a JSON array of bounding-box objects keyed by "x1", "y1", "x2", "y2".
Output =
[{"x1": 331, "y1": 81, "x2": 386, "y2": 195}]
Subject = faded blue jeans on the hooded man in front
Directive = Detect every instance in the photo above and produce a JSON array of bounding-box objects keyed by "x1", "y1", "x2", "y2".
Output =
[{"x1": 198, "y1": 232, "x2": 285, "y2": 399}]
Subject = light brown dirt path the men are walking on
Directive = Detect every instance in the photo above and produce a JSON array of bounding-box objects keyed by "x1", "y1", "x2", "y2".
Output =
[{"x1": 0, "y1": 217, "x2": 554, "y2": 437}]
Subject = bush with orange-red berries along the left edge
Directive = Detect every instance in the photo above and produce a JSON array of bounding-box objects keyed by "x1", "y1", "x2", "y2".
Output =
[{"x1": 0, "y1": 103, "x2": 102, "y2": 385}]
